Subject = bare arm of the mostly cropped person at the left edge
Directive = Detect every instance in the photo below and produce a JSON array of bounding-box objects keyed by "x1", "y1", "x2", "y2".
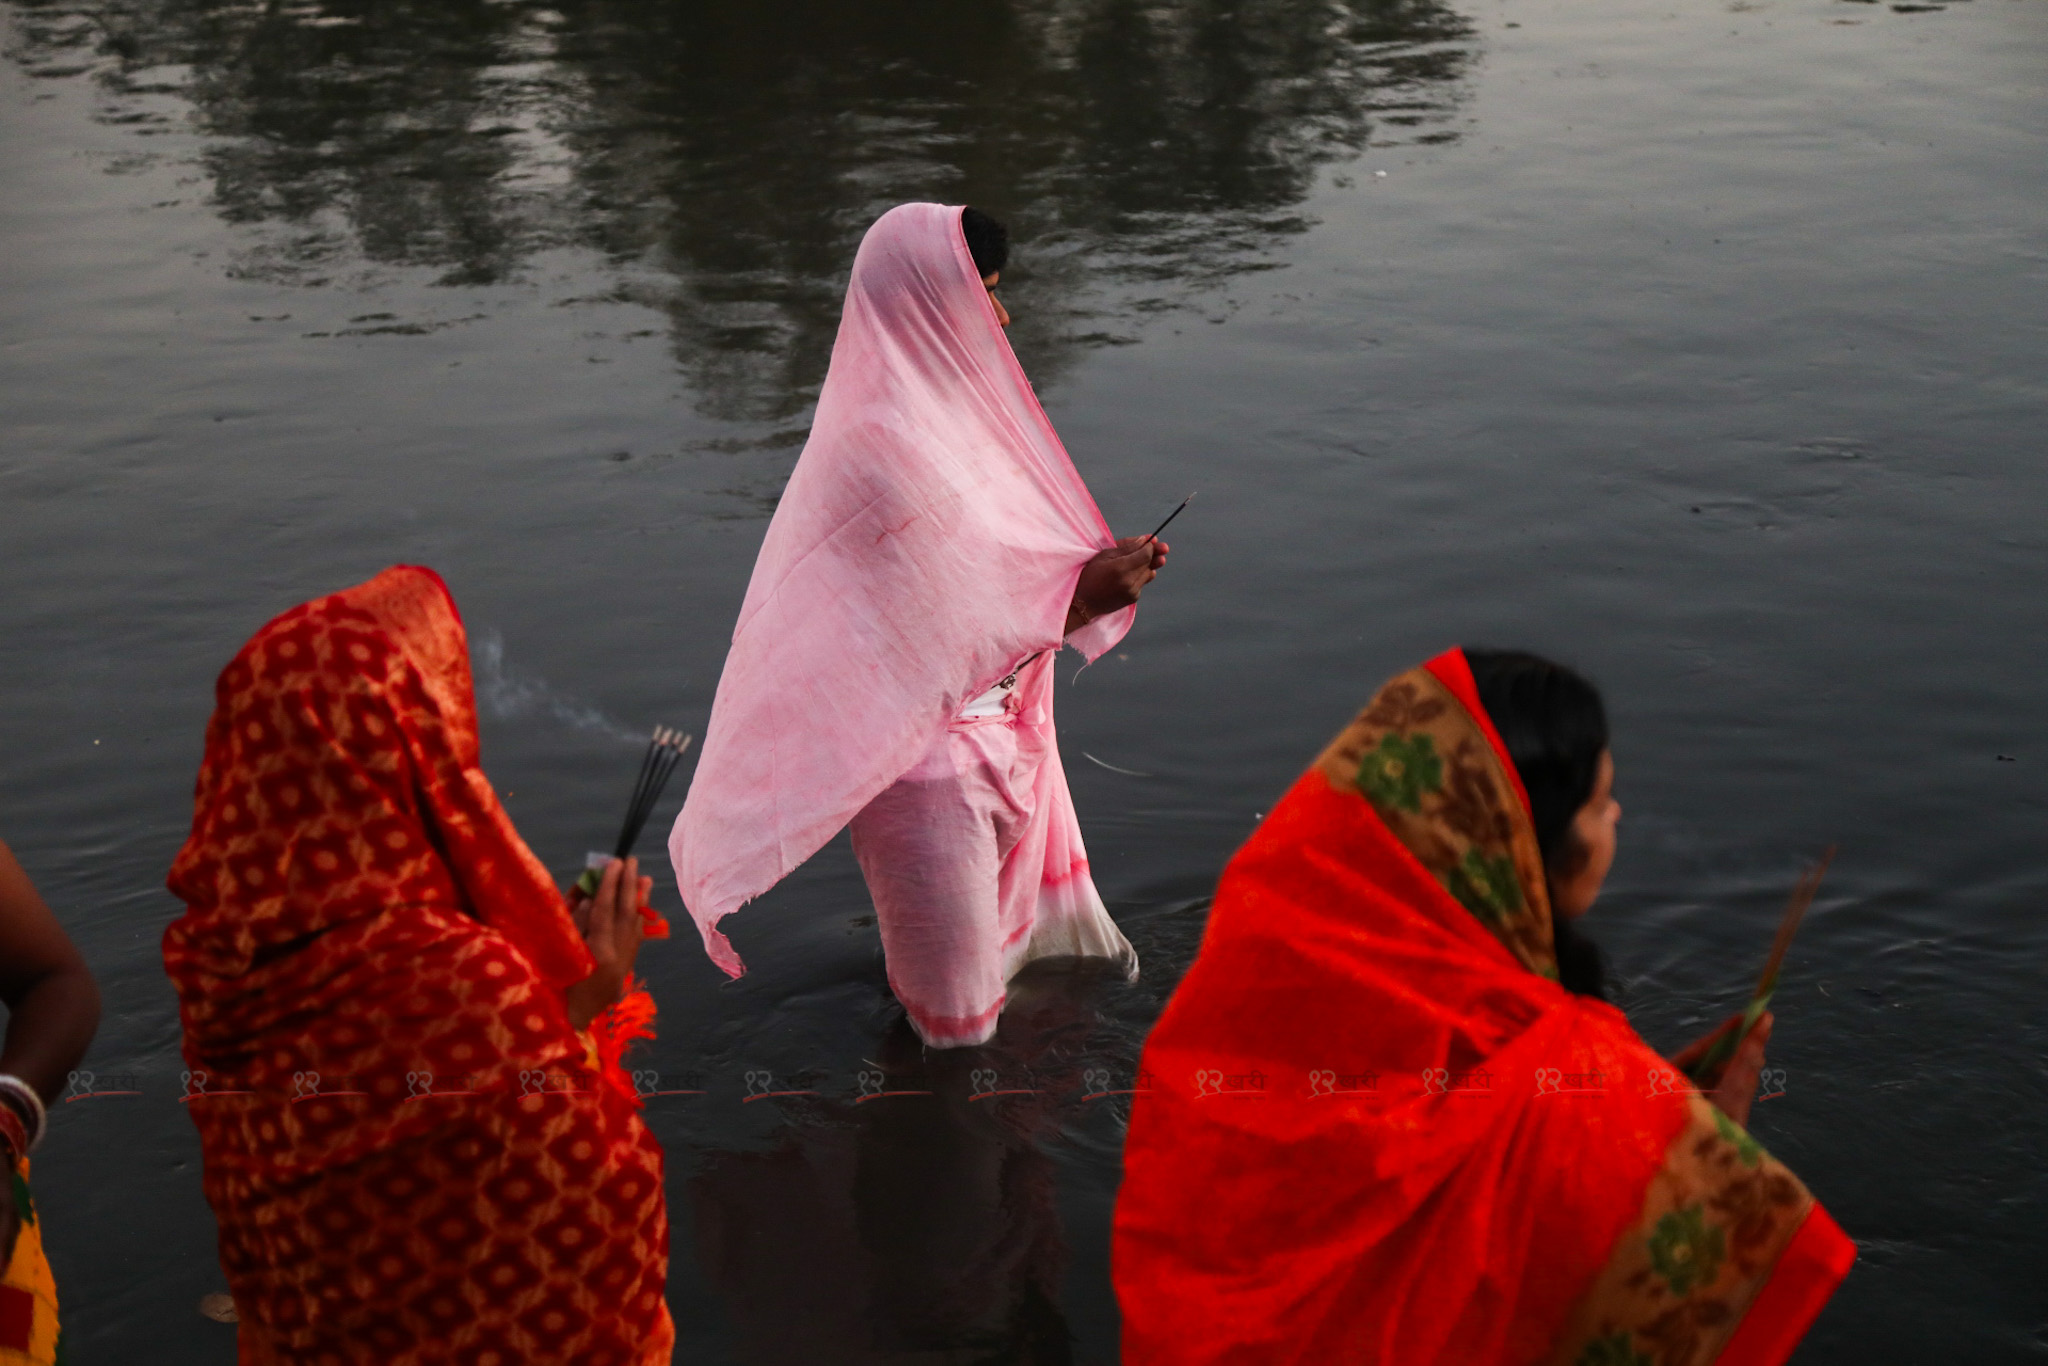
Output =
[{"x1": 0, "y1": 844, "x2": 100, "y2": 1104}]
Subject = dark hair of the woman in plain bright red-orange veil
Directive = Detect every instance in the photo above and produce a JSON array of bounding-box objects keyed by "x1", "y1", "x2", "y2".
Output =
[{"x1": 1464, "y1": 649, "x2": 1608, "y2": 999}]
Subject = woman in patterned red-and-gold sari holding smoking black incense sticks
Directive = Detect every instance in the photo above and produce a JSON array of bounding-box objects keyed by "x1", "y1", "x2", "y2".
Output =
[{"x1": 164, "y1": 565, "x2": 674, "y2": 1366}]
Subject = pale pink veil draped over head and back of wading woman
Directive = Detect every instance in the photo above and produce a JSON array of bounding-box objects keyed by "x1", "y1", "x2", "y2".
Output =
[{"x1": 668, "y1": 205, "x2": 1137, "y2": 977}]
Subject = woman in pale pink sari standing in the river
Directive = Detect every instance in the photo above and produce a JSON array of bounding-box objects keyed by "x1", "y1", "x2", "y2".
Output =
[{"x1": 670, "y1": 205, "x2": 1165, "y2": 1047}]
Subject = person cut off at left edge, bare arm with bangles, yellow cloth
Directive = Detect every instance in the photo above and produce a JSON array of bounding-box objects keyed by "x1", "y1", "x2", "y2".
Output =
[{"x1": 0, "y1": 844, "x2": 100, "y2": 1366}]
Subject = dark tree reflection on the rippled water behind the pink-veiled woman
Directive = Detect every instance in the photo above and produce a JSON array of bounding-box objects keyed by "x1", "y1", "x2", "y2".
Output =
[{"x1": 20, "y1": 0, "x2": 1470, "y2": 422}]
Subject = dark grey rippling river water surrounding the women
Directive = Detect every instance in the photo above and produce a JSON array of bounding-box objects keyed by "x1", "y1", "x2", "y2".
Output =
[{"x1": 0, "y1": 0, "x2": 2048, "y2": 1366}]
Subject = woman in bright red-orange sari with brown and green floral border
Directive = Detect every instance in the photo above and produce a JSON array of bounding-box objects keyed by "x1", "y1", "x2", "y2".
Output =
[{"x1": 1114, "y1": 649, "x2": 1855, "y2": 1366}]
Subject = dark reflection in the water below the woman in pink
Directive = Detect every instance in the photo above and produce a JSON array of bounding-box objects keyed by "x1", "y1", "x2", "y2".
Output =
[{"x1": 690, "y1": 969, "x2": 1116, "y2": 1366}]
